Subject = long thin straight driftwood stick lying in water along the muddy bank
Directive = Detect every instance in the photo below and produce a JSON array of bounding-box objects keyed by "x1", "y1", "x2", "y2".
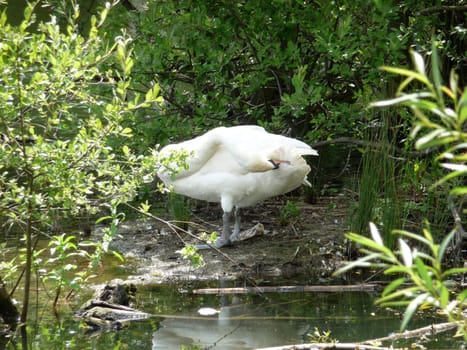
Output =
[{"x1": 193, "y1": 284, "x2": 378, "y2": 295}]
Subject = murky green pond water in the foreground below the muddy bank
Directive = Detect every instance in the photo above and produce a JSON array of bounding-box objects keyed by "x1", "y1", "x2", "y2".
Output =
[{"x1": 20, "y1": 283, "x2": 462, "y2": 350}]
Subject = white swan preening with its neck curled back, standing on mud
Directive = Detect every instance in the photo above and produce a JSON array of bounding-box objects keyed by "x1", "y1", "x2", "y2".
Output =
[{"x1": 158, "y1": 125, "x2": 318, "y2": 247}]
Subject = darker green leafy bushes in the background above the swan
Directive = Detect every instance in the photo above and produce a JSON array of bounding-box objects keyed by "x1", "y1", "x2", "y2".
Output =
[{"x1": 109, "y1": 0, "x2": 424, "y2": 142}]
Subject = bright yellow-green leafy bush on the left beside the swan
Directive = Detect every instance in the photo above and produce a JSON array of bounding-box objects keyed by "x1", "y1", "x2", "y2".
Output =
[{"x1": 0, "y1": 2, "x2": 161, "y2": 322}]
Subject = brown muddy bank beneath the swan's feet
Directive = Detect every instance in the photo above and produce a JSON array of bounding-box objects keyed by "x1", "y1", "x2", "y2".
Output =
[{"x1": 112, "y1": 196, "x2": 349, "y2": 284}]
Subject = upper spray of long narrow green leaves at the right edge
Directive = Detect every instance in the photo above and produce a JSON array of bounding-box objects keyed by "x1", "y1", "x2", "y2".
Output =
[{"x1": 373, "y1": 42, "x2": 467, "y2": 195}]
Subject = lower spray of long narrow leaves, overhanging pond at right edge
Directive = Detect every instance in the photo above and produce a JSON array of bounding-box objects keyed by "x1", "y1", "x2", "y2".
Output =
[{"x1": 337, "y1": 223, "x2": 467, "y2": 335}]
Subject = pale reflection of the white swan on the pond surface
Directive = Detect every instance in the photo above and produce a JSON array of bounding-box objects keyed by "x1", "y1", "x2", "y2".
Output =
[{"x1": 153, "y1": 297, "x2": 309, "y2": 350}]
